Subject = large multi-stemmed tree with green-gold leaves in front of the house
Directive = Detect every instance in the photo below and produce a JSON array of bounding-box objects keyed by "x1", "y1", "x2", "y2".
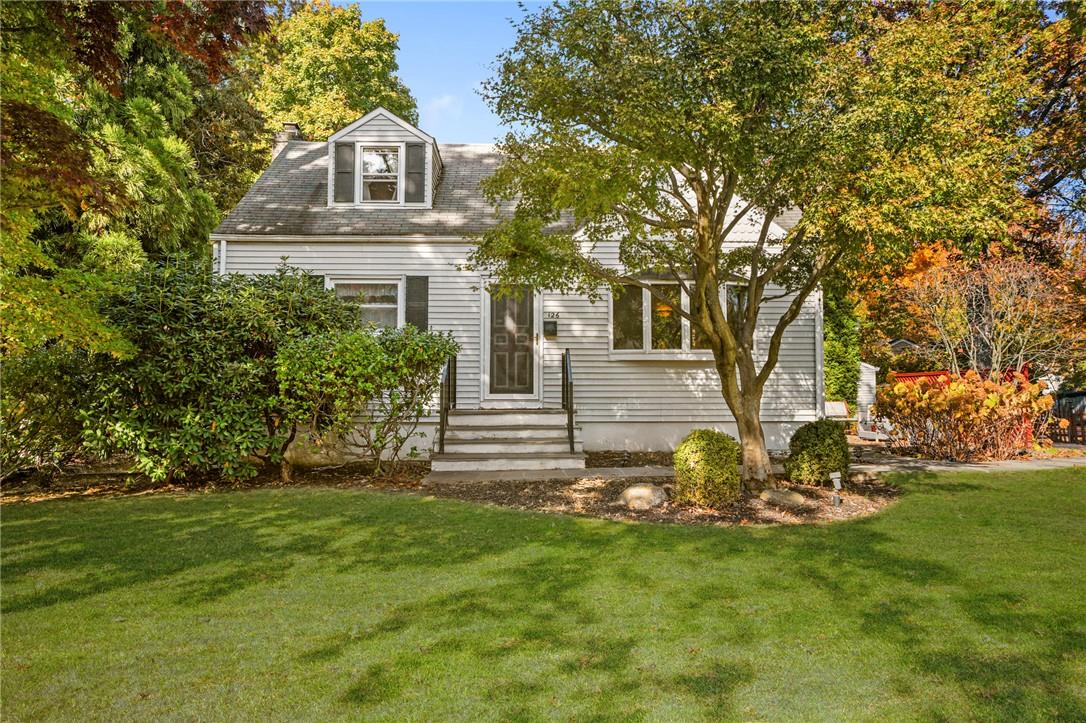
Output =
[{"x1": 472, "y1": 0, "x2": 1035, "y2": 486}]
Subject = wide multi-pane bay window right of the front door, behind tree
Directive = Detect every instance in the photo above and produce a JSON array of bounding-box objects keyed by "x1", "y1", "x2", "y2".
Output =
[{"x1": 610, "y1": 281, "x2": 742, "y2": 358}]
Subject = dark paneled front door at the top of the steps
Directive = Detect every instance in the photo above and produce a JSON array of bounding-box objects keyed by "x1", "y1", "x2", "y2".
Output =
[{"x1": 490, "y1": 287, "x2": 535, "y2": 394}]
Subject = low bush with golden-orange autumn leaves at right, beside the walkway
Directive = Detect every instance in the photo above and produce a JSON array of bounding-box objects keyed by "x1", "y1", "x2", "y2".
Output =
[{"x1": 876, "y1": 371, "x2": 1052, "y2": 460}]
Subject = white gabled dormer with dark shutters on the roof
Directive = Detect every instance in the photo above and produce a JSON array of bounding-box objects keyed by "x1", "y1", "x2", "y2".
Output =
[{"x1": 328, "y1": 107, "x2": 441, "y2": 208}]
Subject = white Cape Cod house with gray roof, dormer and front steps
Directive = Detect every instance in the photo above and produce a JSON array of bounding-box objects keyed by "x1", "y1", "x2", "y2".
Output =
[{"x1": 211, "y1": 109, "x2": 823, "y2": 469}]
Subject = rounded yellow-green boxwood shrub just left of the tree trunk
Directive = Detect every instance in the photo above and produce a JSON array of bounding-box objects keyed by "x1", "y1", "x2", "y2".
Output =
[{"x1": 674, "y1": 429, "x2": 742, "y2": 507}]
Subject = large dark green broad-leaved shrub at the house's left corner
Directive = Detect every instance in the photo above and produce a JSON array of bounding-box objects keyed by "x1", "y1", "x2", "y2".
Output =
[{"x1": 81, "y1": 259, "x2": 359, "y2": 480}]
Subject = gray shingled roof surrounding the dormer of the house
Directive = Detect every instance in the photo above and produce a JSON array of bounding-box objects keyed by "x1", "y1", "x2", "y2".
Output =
[{"x1": 214, "y1": 141, "x2": 512, "y2": 237}]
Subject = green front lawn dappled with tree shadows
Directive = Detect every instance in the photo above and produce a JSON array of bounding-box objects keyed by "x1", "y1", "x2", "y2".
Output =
[{"x1": 0, "y1": 469, "x2": 1086, "y2": 721}]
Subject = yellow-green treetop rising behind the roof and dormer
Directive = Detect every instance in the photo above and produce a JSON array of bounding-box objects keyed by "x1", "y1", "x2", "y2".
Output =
[{"x1": 255, "y1": 0, "x2": 418, "y2": 139}]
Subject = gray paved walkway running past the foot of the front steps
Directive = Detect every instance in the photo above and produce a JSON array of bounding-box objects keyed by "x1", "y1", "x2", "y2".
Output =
[{"x1": 422, "y1": 456, "x2": 1086, "y2": 484}]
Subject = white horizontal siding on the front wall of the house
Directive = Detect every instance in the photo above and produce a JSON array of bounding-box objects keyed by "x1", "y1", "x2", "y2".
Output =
[{"x1": 218, "y1": 240, "x2": 819, "y2": 424}]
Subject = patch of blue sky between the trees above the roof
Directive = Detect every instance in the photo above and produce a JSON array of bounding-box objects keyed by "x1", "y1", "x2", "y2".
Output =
[{"x1": 361, "y1": 0, "x2": 536, "y2": 143}]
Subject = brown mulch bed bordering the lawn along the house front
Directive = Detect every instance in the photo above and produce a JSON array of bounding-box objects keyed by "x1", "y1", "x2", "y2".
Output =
[{"x1": 0, "y1": 465, "x2": 897, "y2": 525}]
